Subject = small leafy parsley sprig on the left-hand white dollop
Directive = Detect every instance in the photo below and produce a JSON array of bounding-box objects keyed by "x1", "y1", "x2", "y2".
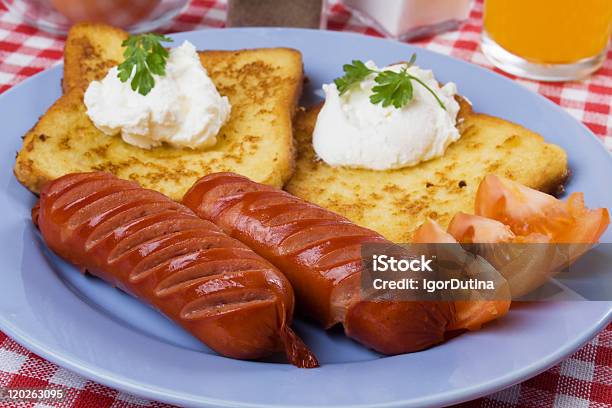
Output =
[{"x1": 117, "y1": 33, "x2": 172, "y2": 95}]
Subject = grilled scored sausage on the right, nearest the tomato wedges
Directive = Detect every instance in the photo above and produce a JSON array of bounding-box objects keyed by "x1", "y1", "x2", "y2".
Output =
[{"x1": 183, "y1": 173, "x2": 454, "y2": 354}]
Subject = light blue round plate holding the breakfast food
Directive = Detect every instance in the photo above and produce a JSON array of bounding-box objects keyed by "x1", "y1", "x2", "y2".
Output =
[{"x1": 0, "y1": 29, "x2": 612, "y2": 407}]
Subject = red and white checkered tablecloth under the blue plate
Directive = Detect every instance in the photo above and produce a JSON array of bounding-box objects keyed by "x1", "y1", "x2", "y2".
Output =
[{"x1": 0, "y1": 0, "x2": 612, "y2": 408}]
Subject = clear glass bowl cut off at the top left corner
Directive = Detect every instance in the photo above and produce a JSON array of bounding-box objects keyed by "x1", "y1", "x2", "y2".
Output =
[{"x1": 0, "y1": 0, "x2": 189, "y2": 35}]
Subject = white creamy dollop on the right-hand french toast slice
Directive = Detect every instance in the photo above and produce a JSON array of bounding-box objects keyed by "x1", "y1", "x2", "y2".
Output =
[{"x1": 312, "y1": 61, "x2": 461, "y2": 170}]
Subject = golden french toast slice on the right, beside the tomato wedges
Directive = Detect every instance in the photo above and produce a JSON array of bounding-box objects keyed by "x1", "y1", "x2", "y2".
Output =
[{"x1": 285, "y1": 99, "x2": 568, "y2": 243}]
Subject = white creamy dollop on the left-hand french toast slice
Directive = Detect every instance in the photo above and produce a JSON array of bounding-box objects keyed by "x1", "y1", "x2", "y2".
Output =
[{"x1": 84, "y1": 41, "x2": 231, "y2": 149}]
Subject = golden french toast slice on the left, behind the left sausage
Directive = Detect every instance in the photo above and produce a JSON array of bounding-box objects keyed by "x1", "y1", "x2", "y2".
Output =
[{"x1": 14, "y1": 24, "x2": 303, "y2": 200}]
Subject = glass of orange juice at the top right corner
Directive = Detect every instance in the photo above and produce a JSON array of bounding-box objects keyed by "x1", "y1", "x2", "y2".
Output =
[{"x1": 482, "y1": 0, "x2": 612, "y2": 81}]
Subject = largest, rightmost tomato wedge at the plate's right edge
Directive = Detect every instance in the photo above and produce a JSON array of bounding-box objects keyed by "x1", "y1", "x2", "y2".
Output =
[{"x1": 468, "y1": 175, "x2": 610, "y2": 297}]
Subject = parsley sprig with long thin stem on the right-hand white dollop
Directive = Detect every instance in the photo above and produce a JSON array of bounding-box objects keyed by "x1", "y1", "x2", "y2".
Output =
[{"x1": 334, "y1": 54, "x2": 446, "y2": 110}]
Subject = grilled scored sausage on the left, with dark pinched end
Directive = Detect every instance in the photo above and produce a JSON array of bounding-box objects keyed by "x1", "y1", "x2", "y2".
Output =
[{"x1": 32, "y1": 173, "x2": 318, "y2": 367}]
